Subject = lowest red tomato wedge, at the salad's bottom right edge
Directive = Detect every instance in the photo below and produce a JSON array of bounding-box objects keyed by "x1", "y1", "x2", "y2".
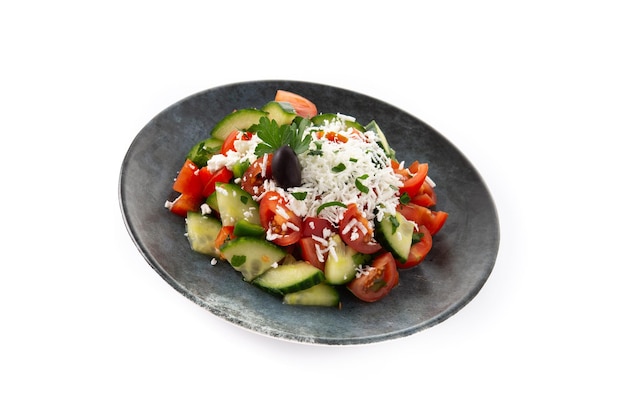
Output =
[{"x1": 347, "y1": 252, "x2": 400, "y2": 303}]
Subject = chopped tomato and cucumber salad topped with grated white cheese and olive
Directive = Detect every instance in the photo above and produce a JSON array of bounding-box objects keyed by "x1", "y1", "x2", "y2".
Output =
[{"x1": 165, "y1": 90, "x2": 448, "y2": 306}]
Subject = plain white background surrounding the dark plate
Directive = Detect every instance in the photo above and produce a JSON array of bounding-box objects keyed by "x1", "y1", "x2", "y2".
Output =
[{"x1": 0, "y1": 0, "x2": 626, "y2": 416}]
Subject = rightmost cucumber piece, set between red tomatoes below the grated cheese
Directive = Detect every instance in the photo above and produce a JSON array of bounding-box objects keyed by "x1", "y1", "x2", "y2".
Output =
[{"x1": 375, "y1": 213, "x2": 415, "y2": 262}]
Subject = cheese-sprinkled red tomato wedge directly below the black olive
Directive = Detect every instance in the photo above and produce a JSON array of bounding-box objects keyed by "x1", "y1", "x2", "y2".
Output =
[{"x1": 259, "y1": 191, "x2": 302, "y2": 246}]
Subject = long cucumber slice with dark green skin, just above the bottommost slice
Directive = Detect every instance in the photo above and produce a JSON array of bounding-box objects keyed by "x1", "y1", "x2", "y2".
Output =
[{"x1": 252, "y1": 261, "x2": 324, "y2": 295}]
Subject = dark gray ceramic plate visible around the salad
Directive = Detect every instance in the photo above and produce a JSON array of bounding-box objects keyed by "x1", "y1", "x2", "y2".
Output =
[{"x1": 119, "y1": 81, "x2": 500, "y2": 345}]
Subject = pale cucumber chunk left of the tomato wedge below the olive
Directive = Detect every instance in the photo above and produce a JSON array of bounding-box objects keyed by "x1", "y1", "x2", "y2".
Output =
[{"x1": 215, "y1": 182, "x2": 261, "y2": 226}]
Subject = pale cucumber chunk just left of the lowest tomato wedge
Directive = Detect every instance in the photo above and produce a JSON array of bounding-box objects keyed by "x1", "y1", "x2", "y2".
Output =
[{"x1": 324, "y1": 235, "x2": 371, "y2": 285}]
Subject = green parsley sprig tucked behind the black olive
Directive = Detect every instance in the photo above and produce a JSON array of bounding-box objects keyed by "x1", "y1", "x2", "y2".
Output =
[{"x1": 252, "y1": 117, "x2": 312, "y2": 156}]
